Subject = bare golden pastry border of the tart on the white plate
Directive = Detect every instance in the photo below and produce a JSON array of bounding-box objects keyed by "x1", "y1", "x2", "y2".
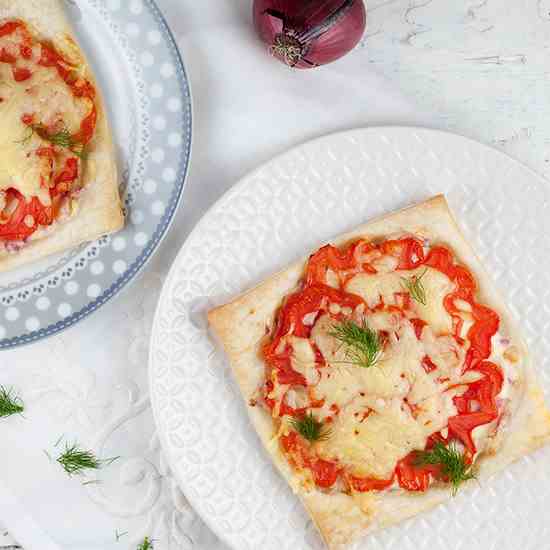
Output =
[{"x1": 208, "y1": 195, "x2": 550, "y2": 550}]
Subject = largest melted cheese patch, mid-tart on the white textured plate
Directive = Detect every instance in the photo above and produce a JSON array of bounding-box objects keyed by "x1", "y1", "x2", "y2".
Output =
[{"x1": 312, "y1": 315, "x2": 466, "y2": 479}]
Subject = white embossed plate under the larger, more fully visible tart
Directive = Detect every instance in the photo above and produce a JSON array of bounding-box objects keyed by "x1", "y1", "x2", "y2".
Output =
[{"x1": 150, "y1": 128, "x2": 550, "y2": 550}]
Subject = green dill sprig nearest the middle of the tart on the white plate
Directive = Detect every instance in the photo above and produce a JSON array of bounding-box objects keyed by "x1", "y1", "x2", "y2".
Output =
[{"x1": 329, "y1": 320, "x2": 382, "y2": 368}]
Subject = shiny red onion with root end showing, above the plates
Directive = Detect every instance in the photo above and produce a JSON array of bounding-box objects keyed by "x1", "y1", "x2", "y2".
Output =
[{"x1": 254, "y1": 0, "x2": 367, "y2": 69}]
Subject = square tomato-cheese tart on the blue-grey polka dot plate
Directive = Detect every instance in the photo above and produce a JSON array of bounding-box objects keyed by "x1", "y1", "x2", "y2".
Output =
[{"x1": 0, "y1": 0, "x2": 124, "y2": 271}]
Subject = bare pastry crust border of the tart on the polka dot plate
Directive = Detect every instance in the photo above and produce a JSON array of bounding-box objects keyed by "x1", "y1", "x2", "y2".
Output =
[{"x1": 0, "y1": 0, "x2": 124, "y2": 272}]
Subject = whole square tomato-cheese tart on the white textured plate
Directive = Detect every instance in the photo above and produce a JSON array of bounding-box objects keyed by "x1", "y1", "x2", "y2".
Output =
[{"x1": 208, "y1": 195, "x2": 550, "y2": 549}]
